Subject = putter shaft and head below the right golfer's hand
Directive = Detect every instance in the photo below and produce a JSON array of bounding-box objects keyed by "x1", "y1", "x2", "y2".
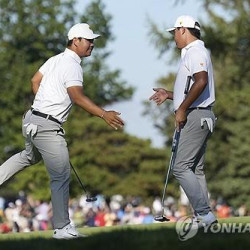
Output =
[{"x1": 154, "y1": 130, "x2": 180, "y2": 222}]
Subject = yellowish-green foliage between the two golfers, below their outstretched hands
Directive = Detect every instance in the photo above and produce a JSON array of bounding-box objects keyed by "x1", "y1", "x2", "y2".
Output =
[{"x1": 66, "y1": 115, "x2": 166, "y2": 205}]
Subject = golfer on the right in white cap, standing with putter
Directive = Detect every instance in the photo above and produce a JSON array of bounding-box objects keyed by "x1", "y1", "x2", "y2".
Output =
[{"x1": 150, "y1": 15, "x2": 217, "y2": 226}]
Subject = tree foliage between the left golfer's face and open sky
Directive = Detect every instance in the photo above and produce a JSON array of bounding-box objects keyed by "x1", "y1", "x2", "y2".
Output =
[{"x1": 81, "y1": 0, "x2": 134, "y2": 105}]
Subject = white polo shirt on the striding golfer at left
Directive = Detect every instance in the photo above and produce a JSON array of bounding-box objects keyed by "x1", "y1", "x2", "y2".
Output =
[{"x1": 32, "y1": 49, "x2": 83, "y2": 123}]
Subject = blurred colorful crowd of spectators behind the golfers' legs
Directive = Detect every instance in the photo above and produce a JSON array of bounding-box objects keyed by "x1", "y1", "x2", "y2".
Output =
[{"x1": 0, "y1": 189, "x2": 249, "y2": 233}]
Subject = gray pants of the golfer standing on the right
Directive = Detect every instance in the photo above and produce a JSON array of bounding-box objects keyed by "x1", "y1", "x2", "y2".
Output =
[{"x1": 173, "y1": 110, "x2": 215, "y2": 215}]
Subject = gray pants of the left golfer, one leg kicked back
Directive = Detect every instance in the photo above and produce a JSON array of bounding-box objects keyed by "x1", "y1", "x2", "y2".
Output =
[{"x1": 0, "y1": 111, "x2": 70, "y2": 228}]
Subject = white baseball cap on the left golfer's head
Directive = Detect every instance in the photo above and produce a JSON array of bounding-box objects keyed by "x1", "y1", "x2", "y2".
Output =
[{"x1": 68, "y1": 23, "x2": 100, "y2": 40}]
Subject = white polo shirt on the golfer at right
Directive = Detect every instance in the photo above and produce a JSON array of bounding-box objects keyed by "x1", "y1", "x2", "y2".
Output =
[{"x1": 173, "y1": 40, "x2": 215, "y2": 111}]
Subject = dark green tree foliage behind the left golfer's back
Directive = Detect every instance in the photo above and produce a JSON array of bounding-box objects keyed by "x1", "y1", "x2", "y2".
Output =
[{"x1": 0, "y1": 0, "x2": 75, "y2": 160}]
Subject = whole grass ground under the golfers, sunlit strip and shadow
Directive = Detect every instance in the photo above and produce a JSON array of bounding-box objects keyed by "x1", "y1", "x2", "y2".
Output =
[{"x1": 0, "y1": 217, "x2": 250, "y2": 250}]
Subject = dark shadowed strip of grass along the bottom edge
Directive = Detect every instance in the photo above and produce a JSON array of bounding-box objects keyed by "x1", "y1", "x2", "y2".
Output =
[{"x1": 0, "y1": 227, "x2": 250, "y2": 250}]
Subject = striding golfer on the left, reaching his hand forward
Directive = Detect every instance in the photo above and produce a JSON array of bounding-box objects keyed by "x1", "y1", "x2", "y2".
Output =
[{"x1": 0, "y1": 23, "x2": 124, "y2": 239}]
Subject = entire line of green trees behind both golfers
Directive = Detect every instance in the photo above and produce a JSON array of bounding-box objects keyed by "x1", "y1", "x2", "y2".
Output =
[{"x1": 0, "y1": 0, "x2": 250, "y2": 208}]
